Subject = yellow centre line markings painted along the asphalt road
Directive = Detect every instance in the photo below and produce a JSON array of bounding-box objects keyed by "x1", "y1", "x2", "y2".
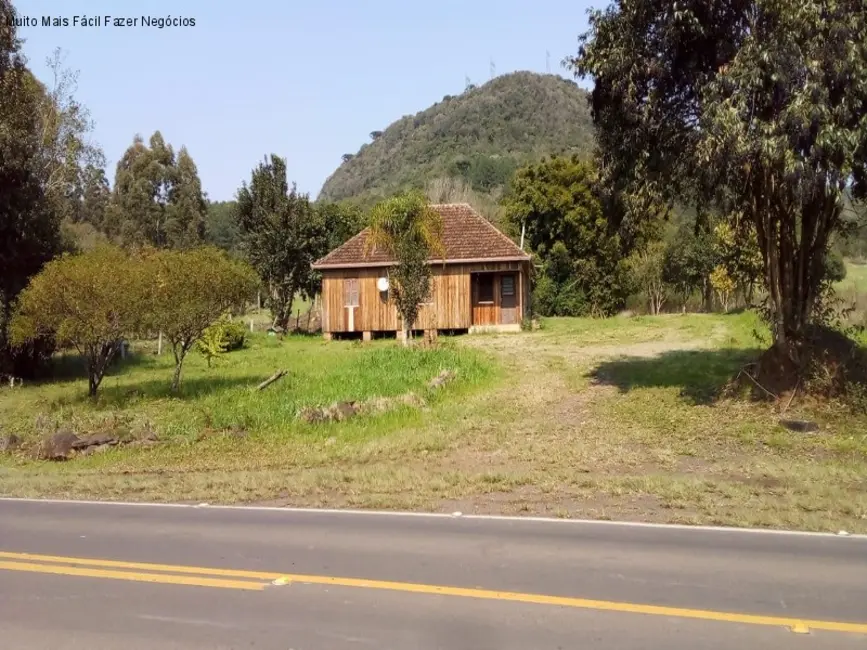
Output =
[{"x1": 0, "y1": 551, "x2": 867, "y2": 634}]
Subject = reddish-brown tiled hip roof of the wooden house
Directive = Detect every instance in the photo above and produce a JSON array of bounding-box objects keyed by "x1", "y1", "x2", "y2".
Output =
[{"x1": 313, "y1": 203, "x2": 530, "y2": 269}]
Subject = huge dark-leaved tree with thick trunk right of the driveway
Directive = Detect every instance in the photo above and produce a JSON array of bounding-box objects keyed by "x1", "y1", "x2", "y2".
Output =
[{"x1": 567, "y1": 0, "x2": 867, "y2": 367}]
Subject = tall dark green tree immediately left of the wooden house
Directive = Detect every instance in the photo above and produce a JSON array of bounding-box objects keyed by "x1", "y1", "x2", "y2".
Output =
[{"x1": 237, "y1": 155, "x2": 327, "y2": 332}]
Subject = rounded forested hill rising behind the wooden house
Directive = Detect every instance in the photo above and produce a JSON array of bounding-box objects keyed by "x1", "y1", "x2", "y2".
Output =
[{"x1": 319, "y1": 72, "x2": 593, "y2": 201}]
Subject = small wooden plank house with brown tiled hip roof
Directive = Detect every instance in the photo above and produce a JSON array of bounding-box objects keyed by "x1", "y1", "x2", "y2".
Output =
[{"x1": 313, "y1": 203, "x2": 530, "y2": 340}]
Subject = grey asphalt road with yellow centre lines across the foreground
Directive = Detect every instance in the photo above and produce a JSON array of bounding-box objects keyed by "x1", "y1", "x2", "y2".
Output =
[{"x1": 0, "y1": 500, "x2": 867, "y2": 650}]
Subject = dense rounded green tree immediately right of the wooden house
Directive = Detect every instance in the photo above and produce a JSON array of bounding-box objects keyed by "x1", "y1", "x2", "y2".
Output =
[{"x1": 503, "y1": 156, "x2": 626, "y2": 316}]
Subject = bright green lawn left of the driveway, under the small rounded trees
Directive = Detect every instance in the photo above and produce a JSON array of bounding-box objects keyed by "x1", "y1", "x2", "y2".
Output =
[{"x1": 0, "y1": 334, "x2": 495, "y2": 458}]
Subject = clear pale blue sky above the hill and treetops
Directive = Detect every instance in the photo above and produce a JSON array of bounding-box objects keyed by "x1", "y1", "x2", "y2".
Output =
[{"x1": 13, "y1": 0, "x2": 603, "y2": 200}]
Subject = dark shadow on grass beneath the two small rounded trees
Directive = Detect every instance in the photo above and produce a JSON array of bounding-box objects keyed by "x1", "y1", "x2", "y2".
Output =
[{"x1": 87, "y1": 373, "x2": 266, "y2": 407}]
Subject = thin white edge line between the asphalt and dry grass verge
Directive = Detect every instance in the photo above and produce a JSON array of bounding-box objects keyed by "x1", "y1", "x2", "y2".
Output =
[{"x1": 0, "y1": 497, "x2": 867, "y2": 540}]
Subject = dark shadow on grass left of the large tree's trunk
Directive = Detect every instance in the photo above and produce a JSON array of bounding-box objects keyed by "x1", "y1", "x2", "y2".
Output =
[{"x1": 588, "y1": 348, "x2": 761, "y2": 404}]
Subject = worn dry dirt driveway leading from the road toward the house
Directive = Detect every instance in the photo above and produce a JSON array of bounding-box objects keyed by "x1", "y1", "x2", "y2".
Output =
[{"x1": 414, "y1": 330, "x2": 725, "y2": 521}]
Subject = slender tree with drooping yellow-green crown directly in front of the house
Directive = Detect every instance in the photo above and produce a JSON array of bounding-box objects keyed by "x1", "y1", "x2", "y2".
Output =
[{"x1": 365, "y1": 192, "x2": 445, "y2": 345}]
